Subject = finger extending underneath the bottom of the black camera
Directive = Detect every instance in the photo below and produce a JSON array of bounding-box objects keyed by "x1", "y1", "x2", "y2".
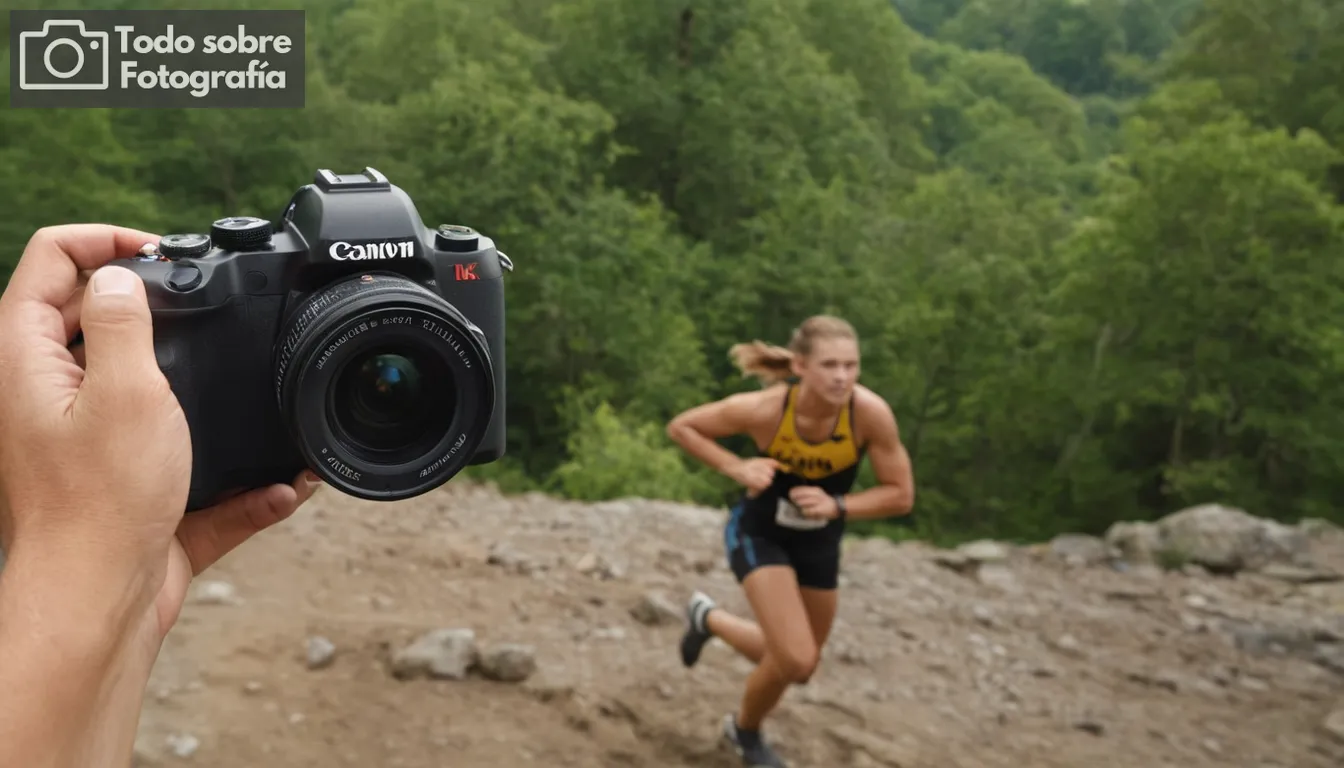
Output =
[{"x1": 177, "y1": 469, "x2": 321, "y2": 576}]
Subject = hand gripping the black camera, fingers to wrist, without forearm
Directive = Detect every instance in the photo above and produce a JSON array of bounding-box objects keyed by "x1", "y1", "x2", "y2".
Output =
[{"x1": 0, "y1": 225, "x2": 317, "y2": 658}]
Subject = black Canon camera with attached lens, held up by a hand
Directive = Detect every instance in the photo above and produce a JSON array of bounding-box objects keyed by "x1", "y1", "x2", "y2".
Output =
[{"x1": 128, "y1": 168, "x2": 513, "y2": 511}]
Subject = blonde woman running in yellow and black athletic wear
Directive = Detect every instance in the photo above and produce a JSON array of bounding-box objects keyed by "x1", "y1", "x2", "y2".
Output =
[{"x1": 668, "y1": 315, "x2": 914, "y2": 768}]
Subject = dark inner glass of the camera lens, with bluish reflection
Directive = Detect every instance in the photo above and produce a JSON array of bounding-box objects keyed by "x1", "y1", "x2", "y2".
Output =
[{"x1": 332, "y1": 347, "x2": 454, "y2": 459}]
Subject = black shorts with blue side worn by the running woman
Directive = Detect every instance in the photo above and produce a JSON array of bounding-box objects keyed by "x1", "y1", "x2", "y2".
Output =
[{"x1": 723, "y1": 504, "x2": 840, "y2": 589}]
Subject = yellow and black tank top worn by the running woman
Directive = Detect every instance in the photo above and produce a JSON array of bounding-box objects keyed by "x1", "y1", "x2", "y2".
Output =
[{"x1": 765, "y1": 382, "x2": 863, "y2": 494}]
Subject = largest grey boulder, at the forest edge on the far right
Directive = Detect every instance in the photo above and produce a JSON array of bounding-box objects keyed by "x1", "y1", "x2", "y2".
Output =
[{"x1": 1157, "y1": 504, "x2": 1308, "y2": 573}]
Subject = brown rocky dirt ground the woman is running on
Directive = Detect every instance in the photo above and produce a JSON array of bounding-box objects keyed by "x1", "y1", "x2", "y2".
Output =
[{"x1": 137, "y1": 483, "x2": 1344, "y2": 768}]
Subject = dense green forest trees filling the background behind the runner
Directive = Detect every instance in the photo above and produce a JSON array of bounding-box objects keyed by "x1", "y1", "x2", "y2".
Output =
[{"x1": 0, "y1": 0, "x2": 1344, "y2": 539}]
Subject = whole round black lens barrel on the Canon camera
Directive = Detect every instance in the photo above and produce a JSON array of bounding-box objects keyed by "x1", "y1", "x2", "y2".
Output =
[{"x1": 276, "y1": 274, "x2": 495, "y2": 500}]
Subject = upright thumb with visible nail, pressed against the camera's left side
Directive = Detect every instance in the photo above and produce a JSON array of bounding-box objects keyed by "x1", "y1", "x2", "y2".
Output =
[{"x1": 79, "y1": 266, "x2": 159, "y2": 394}]
